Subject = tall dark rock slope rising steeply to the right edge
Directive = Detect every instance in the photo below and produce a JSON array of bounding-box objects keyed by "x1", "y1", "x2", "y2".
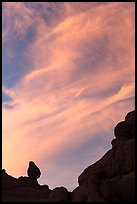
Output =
[{"x1": 72, "y1": 111, "x2": 135, "y2": 202}]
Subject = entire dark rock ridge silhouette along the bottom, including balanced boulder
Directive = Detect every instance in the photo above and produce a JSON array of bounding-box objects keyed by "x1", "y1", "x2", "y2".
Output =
[{"x1": 2, "y1": 111, "x2": 135, "y2": 202}]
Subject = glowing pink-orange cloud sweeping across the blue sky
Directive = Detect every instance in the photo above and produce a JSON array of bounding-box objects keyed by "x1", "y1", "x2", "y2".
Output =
[{"x1": 2, "y1": 2, "x2": 135, "y2": 190}]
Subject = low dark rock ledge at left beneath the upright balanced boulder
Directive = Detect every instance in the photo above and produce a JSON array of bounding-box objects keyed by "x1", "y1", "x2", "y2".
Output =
[{"x1": 2, "y1": 174, "x2": 51, "y2": 202}]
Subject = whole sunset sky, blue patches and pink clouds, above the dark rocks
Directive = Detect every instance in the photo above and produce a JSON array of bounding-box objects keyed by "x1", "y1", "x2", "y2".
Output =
[{"x1": 2, "y1": 2, "x2": 135, "y2": 191}]
